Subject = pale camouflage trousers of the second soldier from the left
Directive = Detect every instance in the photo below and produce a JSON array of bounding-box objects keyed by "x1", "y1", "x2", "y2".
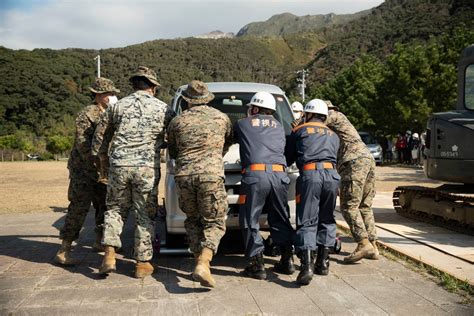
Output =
[{"x1": 102, "y1": 167, "x2": 160, "y2": 261}]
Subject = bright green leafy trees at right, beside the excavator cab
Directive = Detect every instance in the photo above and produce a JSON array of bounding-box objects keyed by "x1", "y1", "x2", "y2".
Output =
[{"x1": 311, "y1": 28, "x2": 474, "y2": 135}]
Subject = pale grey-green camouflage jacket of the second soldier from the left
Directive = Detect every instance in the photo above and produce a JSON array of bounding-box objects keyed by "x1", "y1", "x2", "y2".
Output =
[{"x1": 92, "y1": 91, "x2": 174, "y2": 168}]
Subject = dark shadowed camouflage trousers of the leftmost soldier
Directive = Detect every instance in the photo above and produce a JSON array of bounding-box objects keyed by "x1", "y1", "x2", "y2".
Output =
[{"x1": 59, "y1": 172, "x2": 107, "y2": 241}]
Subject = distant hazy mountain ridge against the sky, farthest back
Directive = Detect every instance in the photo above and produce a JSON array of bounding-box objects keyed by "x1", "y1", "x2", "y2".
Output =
[{"x1": 237, "y1": 10, "x2": 370, "y2": 37}]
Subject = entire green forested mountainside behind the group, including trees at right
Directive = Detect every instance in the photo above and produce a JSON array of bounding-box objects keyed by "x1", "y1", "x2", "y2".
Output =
[{"x1": 0, "y1": 0, "x2": 474, "y2": 157}]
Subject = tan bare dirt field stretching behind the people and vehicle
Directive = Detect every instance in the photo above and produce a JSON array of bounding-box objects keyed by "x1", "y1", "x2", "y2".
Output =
[{"x1": 0, "y1": 161, "x2": 440, "y2": 214}]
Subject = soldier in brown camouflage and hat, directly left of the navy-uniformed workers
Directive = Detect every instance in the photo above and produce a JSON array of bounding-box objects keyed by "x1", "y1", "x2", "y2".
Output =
[{"x1": 168, "y1": 80, "x2": 232, "y2": 287}]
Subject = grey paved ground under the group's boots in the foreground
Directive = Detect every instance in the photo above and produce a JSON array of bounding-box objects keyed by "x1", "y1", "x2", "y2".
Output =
[{"x1": 0, "y1": 212, "x2": 474, "y2": 315}]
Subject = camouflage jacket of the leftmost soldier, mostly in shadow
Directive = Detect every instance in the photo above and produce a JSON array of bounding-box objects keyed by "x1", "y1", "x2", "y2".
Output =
[{"x1": 68, "y1": 104, "x2": 104, "y2": 176}]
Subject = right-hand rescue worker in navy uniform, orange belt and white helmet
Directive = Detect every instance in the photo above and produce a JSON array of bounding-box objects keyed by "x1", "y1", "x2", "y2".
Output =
[{"x1": 285, "y1": 99, "x2": 340, "y2": 285}]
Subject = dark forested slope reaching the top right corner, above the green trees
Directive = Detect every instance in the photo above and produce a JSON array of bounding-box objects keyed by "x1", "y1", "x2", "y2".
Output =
[{"x1": 309, "y1": 0, "x2": 474, "y2": 84}]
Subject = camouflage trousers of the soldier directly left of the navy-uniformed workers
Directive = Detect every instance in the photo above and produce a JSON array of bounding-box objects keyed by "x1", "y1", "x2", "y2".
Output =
[{"x1": 175, "y1": 174, "x2": 228, "y2": 254}]
